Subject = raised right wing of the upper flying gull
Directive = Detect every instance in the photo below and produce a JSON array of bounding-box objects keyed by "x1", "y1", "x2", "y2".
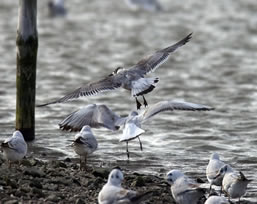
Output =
[{"x1": 129, "y1": 33, "x2": 192, "y2": 75}]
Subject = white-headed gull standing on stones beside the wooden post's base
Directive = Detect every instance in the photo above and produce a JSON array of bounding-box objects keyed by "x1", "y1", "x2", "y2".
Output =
[{"x1": 1, "y1": 130, "x2": 28, "y2": 167}]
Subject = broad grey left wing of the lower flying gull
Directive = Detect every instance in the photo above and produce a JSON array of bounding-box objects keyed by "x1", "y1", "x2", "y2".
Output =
[{"x1": 59, "y1": 104, "x2": 120, "y2": 131}]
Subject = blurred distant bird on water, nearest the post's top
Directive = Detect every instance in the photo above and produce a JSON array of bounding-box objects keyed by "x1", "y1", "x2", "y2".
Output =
[{"x1": 48, "y1": 0, "x2": 67, "y2": 17}]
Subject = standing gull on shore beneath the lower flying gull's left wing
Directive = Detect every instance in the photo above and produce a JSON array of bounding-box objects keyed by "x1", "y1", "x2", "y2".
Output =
[{"x1": 72, "y1": 125, "x2": 98, "y2": 169}]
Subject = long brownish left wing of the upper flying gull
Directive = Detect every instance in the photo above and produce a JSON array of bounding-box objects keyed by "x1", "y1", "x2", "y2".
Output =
[{"x1": 37, "y1": 74, "x2": 123, "y2": 107}]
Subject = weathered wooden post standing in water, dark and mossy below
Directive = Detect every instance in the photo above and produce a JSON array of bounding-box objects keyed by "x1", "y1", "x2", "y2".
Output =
[{"x1": 16, "y1": 0, "x2": 38, "y2": 141}]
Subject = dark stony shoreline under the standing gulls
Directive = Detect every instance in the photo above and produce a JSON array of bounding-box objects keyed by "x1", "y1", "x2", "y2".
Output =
[{"x1": 0, "y1": 148, "x2": 252, "y2": 204}]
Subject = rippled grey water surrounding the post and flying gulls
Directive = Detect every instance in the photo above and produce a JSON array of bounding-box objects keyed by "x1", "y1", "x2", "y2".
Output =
[{"x1": 0, "y1": 0, "x2": 257, "y2": 202}]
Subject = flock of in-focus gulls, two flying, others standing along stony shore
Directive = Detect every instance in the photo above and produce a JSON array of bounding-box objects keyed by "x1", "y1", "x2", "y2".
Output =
[{"x1": 1, "y1": 34, "x2": 251, "y2": 204}]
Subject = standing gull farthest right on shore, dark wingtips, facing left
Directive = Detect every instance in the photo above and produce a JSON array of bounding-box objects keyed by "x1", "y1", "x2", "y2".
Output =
[{"x1": 214, "y1": 164, "x2": 252, "y2": 203}]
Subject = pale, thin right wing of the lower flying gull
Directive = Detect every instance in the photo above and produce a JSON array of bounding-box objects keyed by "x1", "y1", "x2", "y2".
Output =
[{"x1": 141, "y1": 100, "x2": 214, "y2": 121}]
